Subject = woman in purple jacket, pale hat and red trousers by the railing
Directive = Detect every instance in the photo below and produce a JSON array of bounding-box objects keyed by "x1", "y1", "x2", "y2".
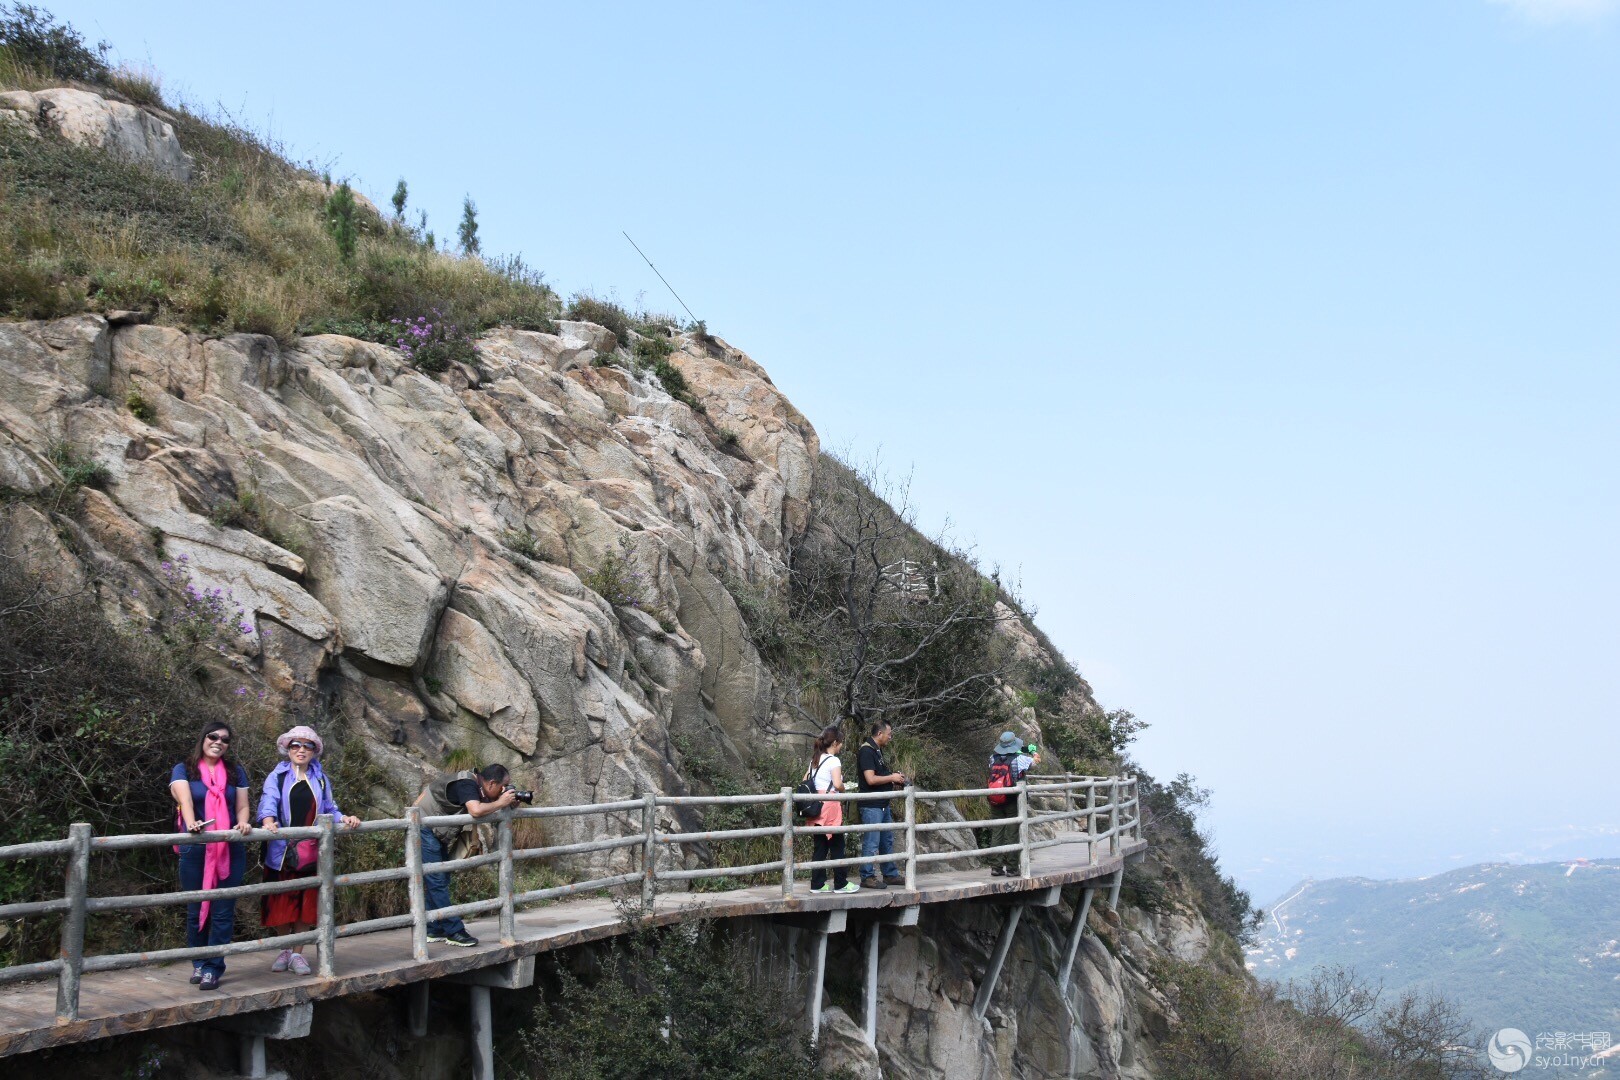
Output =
[{"x1": 258, "y1": 725, "x2": 360, "y2": 975}]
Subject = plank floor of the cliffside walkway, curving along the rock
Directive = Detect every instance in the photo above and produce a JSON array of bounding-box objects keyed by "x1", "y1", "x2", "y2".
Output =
[{"x1": 0, "y1": 839, "x2": 1147, "y2": 1057}]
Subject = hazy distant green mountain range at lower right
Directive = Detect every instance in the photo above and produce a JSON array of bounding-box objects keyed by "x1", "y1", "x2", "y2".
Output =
[{"x1": 1247, "y1": 860, "x2": 1620, "y2": 1042}]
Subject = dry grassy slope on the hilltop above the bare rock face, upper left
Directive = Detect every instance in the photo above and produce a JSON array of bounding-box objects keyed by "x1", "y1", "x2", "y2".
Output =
[{"x1": 0, "y1": 58, "x2": 559, "y2": 342}]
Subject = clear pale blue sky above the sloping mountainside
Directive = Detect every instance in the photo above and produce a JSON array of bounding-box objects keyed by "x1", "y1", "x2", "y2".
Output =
[{"x1": 49, "y1": 0, "x2": 1620, "y2": 900}]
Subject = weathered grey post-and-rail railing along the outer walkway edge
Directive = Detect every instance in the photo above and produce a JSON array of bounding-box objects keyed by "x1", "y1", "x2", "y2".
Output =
[{"x1": 0, "y1": 776, "x2": 1140, "y2": 1023}]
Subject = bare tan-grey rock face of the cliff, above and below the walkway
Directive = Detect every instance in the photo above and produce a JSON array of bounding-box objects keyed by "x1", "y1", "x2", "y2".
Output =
[{"x1": 0, "y1": 316, "x2": 1209, "y2": 1078}]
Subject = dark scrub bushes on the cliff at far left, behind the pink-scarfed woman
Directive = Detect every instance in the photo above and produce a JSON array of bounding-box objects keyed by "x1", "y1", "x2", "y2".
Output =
[{"x1": 0, "y1": 531, "x2": 261, "y2": 963}]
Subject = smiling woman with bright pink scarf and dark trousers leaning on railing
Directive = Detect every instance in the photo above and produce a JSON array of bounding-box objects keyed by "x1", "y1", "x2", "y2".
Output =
[{"x1": 168, "y1": 724, "x2": 253, "y2": 989}]
